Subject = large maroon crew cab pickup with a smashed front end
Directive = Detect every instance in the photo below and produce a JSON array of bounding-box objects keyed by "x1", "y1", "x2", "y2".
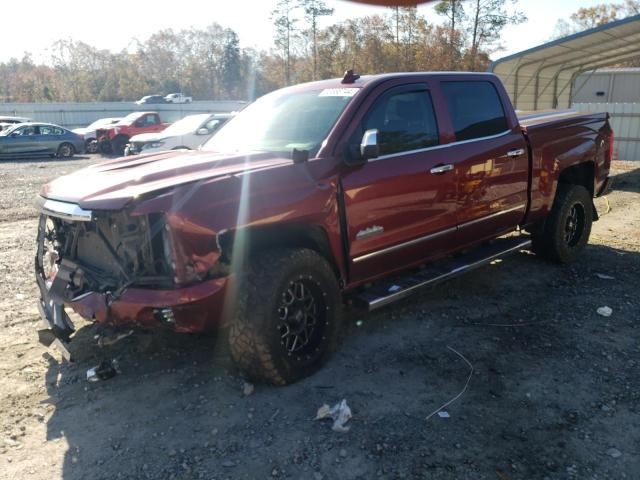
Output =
[{"x1": 35, "y1": 71, "x2": 613, "y2": 384}]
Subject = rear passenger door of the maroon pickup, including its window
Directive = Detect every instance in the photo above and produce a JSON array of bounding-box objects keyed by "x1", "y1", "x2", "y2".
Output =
[{"x1": 440, "y1": 79, "x2": 529, "y2": 246}]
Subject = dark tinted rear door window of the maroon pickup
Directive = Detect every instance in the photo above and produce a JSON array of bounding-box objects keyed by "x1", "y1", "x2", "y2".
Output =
[{"x1": 442, "y1": 82, "x2": 509, "y2": 141}]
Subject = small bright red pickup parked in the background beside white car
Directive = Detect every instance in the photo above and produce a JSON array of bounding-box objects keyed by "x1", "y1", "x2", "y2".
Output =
[{"x1": 96, "y1": 112, "x2": 169, "y2": 155}]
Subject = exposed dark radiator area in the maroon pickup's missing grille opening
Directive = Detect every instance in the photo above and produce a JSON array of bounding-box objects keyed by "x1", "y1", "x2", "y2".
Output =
[{"x1": 36, "y1": 212, "x2": 173, "y2": 301}]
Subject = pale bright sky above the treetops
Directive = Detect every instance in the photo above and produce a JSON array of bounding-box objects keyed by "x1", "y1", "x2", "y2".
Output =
[{"x1": 0, "y1": 0, "x2": 620, "y2": 62}]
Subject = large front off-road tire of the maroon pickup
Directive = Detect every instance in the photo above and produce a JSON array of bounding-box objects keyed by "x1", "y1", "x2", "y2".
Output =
[{"x1": 229, "y1": 249, "x2": 342, "y2": 385}]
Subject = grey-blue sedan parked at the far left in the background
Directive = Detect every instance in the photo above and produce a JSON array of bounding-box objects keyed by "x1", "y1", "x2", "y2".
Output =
[{"x1": 0, "y1": 122, "x2": 84, "y2": 158}]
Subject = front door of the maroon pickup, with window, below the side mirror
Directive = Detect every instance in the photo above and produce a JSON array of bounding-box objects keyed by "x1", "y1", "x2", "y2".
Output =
[{"x1": 342, "y1": 83, "x2": 457, "y2": 282}]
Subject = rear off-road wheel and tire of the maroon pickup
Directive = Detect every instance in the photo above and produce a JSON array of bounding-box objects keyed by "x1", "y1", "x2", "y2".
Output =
[{"x1": 532, "y1": 183, "x2": 593, "y2": 263}]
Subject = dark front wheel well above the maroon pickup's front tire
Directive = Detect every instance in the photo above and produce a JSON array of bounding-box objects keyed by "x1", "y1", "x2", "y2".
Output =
[{"x1": 217, "y1": 224, "x2": 339, "y2": 277}]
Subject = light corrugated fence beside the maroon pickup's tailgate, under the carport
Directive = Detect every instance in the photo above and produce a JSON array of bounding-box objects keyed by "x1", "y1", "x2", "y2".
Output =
[{"x1": 571, "y1": 103, "x2": 640, "y2": 160}]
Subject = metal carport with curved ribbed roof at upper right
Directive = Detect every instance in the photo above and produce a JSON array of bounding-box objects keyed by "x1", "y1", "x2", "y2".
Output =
[{"x1": 489, "y1": 15, "x2": 640, "y2": 110}]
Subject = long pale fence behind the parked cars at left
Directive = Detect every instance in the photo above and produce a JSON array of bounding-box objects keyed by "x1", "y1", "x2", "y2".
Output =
[{"x1": 0, "y1": 101, "x2": 247, "y2": 128}]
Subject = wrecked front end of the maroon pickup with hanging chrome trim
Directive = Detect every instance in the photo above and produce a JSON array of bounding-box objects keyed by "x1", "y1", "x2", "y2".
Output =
[{"x1": 35, "y1": 199, "x2": 175, "y2": 345}]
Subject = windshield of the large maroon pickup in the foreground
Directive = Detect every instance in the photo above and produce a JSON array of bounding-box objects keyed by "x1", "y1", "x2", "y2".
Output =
[{"x1": 202, "y1": 88, "x2": 359, "y2": 157}]
